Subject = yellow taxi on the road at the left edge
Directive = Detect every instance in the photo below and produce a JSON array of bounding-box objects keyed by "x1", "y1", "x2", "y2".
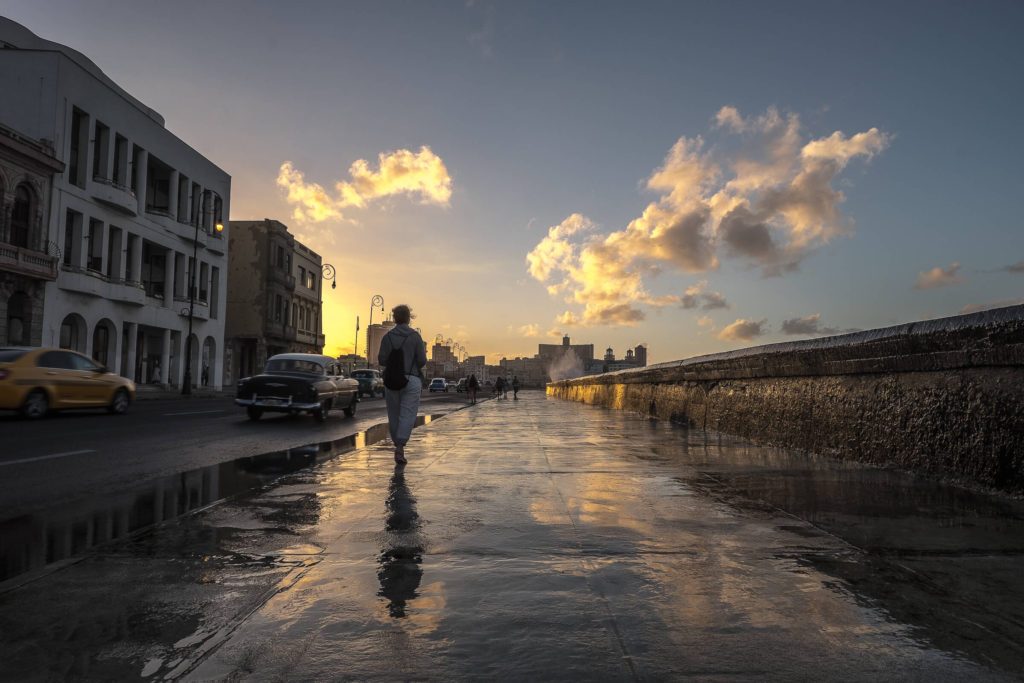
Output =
[{"x1": 0, "y1": 346, "x2": 135, "y2": 419}]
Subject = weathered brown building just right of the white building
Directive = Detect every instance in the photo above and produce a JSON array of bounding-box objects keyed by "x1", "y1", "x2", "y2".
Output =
[{"x1": 226, "y1": 218, "x2": 325, "y2": 384}]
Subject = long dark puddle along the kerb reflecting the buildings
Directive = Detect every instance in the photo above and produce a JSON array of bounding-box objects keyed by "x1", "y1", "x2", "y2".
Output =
[{"x1": 0, "y1": 415, "x2": 440, "y2": 592}]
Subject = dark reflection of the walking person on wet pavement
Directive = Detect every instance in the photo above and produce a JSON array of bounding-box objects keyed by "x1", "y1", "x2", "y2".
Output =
[{"x1": 377, "y1": 466, "x2": 423, "y2": 618}]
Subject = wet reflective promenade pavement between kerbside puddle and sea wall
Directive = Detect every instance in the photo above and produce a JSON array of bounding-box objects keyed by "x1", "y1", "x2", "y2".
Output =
[{"x1": 0, "y1": 393, "x2": 1024, "y2": 680}]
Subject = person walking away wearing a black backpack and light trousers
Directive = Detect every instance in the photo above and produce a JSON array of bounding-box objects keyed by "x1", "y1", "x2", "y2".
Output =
[{"x1": 377, "y1": 304, "x2": 427, "y2": 465}]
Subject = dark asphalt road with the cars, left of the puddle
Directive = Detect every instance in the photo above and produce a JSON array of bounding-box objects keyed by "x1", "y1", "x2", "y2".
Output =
[{"x1": 0, "y1": 393, "x2": 466, "y2": 520}]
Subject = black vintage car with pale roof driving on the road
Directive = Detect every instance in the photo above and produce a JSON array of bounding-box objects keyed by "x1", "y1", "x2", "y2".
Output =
[{"x1": 234, "y1": 353, "x2": 359, "y2": 422}]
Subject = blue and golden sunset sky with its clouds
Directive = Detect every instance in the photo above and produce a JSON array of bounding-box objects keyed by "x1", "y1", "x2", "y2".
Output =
[{"x1": 0, "y1": 0, "x2": 1024, "y2": 361}]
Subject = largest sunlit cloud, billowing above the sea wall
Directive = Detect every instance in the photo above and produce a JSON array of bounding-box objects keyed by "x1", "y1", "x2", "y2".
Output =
[{"x1": 526, "y1": 106, "x2": 891, "y2": 325}]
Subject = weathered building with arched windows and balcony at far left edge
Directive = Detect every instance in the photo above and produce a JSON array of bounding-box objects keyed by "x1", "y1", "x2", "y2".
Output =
[{"x1": 0, "y1": 126, "x2": 63, "y2": 346}]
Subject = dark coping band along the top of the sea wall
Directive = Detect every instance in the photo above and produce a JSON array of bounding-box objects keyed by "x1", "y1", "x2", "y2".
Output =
[{"x1": 552, "y1": 305, "x2": 1024, "y2": 385}]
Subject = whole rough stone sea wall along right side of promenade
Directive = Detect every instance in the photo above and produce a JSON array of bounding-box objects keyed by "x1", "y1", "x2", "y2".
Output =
[{"x1": 548, "y1": 305, "x2": 1024, "y2": 493}]
